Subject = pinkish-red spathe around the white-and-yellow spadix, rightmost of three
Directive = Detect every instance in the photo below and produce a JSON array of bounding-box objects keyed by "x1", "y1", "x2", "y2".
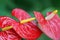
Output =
[{"x1": 34, "y1": 12, "x2": 60, "y2": 40}]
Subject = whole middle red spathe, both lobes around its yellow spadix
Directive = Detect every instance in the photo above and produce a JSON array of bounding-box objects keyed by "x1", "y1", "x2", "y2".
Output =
[{"x1": 12, "y1": 8, "x2": 42, "y2": 40}]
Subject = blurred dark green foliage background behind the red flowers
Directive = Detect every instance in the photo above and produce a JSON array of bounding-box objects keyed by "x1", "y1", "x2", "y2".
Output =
[{"x1": 0, "y1": 0, "x2": 60, "y2": 40}]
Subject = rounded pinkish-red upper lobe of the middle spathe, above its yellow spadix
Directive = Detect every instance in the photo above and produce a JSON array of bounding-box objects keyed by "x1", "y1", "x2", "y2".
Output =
[{"x1": 12, "y1": 8, "x2": 31, "y2": 21}]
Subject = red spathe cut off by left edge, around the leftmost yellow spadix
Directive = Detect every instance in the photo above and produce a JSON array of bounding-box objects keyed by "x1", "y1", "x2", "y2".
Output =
[{"x1": 0, "y1": 16, "x2": 21, "y2": 40}]
